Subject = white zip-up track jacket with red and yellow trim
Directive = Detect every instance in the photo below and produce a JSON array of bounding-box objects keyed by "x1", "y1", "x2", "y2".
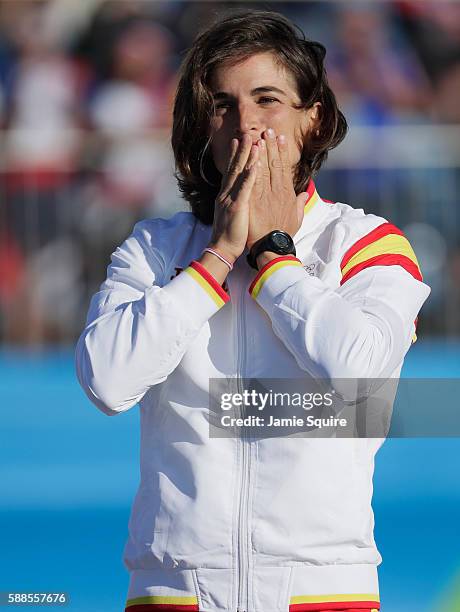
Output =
[{"x1": 76, "y1": 181, "x2": 430, "y2": 612}]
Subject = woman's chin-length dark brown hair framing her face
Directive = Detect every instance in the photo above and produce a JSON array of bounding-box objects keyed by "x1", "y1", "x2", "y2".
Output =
[{"x1": 171, "y1": 10, "x2": 347, "y2": 224}]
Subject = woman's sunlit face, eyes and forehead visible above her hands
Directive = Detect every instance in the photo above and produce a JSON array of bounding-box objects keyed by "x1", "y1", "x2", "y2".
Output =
[{"x1": 210, "y1": 52, "x2": 317, "y2": 174}]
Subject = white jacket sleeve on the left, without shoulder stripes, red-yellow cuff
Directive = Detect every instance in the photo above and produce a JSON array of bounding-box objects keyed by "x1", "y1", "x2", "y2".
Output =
[{"x1": 76, "y1": 222, "x2": 229, "y2": 415}]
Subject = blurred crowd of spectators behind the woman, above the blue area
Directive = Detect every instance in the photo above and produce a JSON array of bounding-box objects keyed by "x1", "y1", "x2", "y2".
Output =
[{"x1": 0, "y1": 0, "x2": 460, "y2": 345}]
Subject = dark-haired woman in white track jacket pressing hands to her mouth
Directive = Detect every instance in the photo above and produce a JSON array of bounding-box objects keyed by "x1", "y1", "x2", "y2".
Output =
[{"x1": 77, "y1": 11, "x2": 429, "y2": 612}]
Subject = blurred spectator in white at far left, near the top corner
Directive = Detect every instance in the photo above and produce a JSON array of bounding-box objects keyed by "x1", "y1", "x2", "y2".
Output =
[{"x1": 7, "y1": 4, "x2": 79, "y2": 180}]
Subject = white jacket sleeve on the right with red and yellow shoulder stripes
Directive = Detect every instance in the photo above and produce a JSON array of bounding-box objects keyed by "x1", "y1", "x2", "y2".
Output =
[{"x1": 250, "y1": 223, "x2": 430, "y2": 380}]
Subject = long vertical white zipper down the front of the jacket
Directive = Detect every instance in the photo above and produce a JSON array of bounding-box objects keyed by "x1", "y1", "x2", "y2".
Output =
[{"x1": 237, "y1": 283, "x2": 250, "y2": 612}]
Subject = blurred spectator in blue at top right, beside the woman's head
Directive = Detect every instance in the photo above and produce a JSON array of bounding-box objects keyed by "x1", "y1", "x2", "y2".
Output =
[{"x1": 328, "y1": 3, "x2": 430, "y2": 125}]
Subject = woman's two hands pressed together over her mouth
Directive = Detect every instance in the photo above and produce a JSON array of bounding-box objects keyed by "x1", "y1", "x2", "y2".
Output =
[{"x1": 211, "y1": 129, "x2": 306, "y2": 261}]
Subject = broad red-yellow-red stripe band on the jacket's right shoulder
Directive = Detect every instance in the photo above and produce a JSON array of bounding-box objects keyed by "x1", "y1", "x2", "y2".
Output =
[{"x1": 340, "y1": 223, "x2": 423, "y2": 285}]
